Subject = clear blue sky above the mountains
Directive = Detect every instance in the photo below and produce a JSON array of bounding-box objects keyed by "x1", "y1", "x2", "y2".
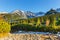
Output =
[{"x1": 0, "y1": 0, "x2": 60, "y2": 12}]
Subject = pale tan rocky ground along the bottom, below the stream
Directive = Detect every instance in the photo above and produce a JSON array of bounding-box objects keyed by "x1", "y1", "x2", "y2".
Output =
[{"x1": 0, "y1": 34, "x2": 59, "y2": 40}]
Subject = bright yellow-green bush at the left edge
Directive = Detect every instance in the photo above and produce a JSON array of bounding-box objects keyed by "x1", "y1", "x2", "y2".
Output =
[{"x1": 0, "y1": 20, "x2": 11, "y2": 33}]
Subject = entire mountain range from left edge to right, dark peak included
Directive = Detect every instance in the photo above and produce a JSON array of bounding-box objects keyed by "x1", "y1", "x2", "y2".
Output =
[{"x1": 0, "y1": 9, "x2": 60, "y2": 22}]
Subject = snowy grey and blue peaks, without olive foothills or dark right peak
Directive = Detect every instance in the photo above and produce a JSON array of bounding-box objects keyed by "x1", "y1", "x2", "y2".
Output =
[{"x1": 12, "y1": 10, "x2": 45, "y2": 19}]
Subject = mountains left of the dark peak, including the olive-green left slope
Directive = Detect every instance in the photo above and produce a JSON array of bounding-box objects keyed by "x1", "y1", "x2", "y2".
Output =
[{"x1": 0, "y1": 10, "x2": 45, "y2": 20}]
